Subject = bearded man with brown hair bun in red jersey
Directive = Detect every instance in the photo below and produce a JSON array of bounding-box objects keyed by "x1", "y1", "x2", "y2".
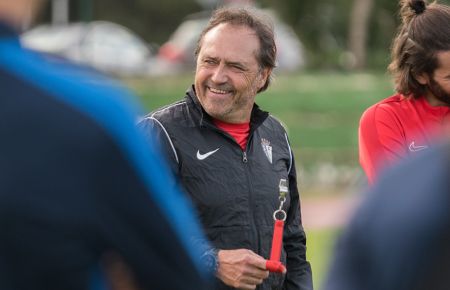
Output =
[{"x1": 359, "y1": 0, "x2": 450, "y2": 183}]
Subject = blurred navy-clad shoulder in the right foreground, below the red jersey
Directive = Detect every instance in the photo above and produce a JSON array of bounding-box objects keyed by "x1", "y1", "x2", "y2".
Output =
[{"x1": 324, "y1": 139, "x2": 450, "y2": 290}]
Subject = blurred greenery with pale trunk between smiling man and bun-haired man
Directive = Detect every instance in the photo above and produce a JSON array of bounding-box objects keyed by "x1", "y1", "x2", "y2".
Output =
[{"x1": 258, "y1": 0, "x2": 412, "y2": 70}]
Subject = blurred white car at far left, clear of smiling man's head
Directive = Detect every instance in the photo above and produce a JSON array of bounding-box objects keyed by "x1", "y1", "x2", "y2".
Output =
[{"x1": 21, "y1": 21, "x2": 154, "y2": 76}]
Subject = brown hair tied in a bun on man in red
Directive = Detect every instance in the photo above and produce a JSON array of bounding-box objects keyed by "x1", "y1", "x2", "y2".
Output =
[{"x1": 388, "y1": 0, "x2": 450, "y2": 98}]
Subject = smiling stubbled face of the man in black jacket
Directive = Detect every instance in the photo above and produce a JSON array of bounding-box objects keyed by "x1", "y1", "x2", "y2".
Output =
[{"x1": 195, "y1": 24, "x2": 270, "y2": 123}]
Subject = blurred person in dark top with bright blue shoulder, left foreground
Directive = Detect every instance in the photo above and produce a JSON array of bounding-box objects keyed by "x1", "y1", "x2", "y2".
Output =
[{"x1": 0, "y1": 0, "x2": 210, "y2": 290}]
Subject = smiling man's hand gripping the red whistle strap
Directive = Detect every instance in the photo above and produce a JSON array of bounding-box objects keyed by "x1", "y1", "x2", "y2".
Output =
[{"x1": 216, "y1": 249, "x2": 269, "y2": 289}]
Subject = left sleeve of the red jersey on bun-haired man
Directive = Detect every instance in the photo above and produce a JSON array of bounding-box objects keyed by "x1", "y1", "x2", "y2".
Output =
[{"x1": 359, "y1": 105, "x2": 407, "y2": 184}]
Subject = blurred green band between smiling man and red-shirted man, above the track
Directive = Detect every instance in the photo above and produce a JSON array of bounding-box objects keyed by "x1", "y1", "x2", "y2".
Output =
[{"x1": 253, "y1": 73, "x2": 392, "y2": 169}]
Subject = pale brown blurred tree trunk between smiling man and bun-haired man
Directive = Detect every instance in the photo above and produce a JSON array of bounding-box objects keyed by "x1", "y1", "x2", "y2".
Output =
[{"x1": 349, "y1": 0, "x2": 374, "y2": 69}]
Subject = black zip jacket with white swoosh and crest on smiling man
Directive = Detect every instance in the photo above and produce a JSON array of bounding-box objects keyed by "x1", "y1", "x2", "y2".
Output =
[{"x1": 139, "y1": 87, "x2": 312, "y2": 290}]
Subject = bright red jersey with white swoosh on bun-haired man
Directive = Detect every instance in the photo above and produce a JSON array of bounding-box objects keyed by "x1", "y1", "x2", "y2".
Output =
[{"x1": 359, "y1": 94, "x2": 450, "y2": 183}]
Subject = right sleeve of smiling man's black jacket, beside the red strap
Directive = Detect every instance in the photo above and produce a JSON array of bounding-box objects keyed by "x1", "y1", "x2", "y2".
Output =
[{"x1": 283, "y1": 138, "x2": 313, "y2": 290}]
